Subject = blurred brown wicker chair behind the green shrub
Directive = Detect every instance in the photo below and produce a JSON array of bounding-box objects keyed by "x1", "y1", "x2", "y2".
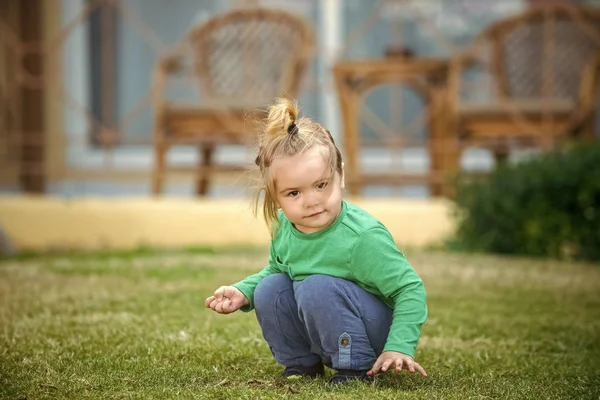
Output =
[{"x1": 442, "y1": 5, "x2": 600, "y2": 192}]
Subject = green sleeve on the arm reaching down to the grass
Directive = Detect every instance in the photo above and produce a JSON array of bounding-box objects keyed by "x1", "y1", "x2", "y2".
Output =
[{"x1": 350, "y1": 227, "x2": 428, "y2": 357}]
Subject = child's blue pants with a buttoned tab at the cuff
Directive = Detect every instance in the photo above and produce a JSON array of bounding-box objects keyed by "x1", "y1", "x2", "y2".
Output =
[{"x1": 254, "y1": 274, "x2": 392, "y2": 370}]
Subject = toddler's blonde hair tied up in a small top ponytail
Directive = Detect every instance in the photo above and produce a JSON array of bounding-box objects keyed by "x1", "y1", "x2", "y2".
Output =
[{"x1": 253, "y1": 98, "x2": 342, "y2": 235}]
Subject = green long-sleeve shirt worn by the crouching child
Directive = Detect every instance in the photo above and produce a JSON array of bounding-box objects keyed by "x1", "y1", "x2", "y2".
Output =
[{"x1": 234, "y1": 201, "x2": 427, "y2": 357}]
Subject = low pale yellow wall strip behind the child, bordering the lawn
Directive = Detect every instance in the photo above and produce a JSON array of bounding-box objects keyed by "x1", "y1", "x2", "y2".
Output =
[{"x1": 0, "y1": 197, "x2": 452, "y2": 250}]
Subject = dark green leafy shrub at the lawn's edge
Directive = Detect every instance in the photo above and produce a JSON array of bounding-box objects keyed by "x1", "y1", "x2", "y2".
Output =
[{"x1": 455, "y1": 143, "x2": 600, "y2": 261}]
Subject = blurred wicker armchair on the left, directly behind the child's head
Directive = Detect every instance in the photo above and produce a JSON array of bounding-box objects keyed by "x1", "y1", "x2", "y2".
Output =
[{"x1": 152, "y1": 8, "x2": 313, "y2": 195}]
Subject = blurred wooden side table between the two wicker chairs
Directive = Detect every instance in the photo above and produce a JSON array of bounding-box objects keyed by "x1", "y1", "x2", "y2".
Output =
[{"x1": 333, "y1": 57, "x2": 449, "y2": 196}]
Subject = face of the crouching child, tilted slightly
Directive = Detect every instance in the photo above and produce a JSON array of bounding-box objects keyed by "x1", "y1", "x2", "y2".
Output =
[{"x1": 271, "y1": 146, "x2": 343, "y2": 233}]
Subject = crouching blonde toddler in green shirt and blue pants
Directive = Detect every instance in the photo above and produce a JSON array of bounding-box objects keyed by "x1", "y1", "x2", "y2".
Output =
[{"x1": 205, "y1": 99, "x2": 427, "y2": 384}]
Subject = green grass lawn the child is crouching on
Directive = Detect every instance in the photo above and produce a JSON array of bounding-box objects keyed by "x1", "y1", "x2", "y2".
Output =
[{"x1": 0, "y1": 249, "x2": 600, "y2": 400}]
